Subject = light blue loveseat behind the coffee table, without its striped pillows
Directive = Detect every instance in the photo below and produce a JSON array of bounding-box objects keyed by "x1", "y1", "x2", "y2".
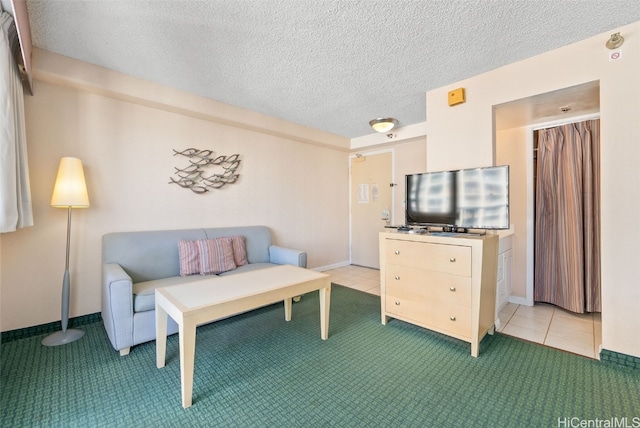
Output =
[{"x1": 102, "y1": 226, "x2": 307, "y2": 356}]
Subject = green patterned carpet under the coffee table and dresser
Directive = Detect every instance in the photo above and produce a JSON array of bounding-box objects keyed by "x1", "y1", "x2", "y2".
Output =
[{"x1": 0, "y1": 286, "x2": 640, "y2": 427}]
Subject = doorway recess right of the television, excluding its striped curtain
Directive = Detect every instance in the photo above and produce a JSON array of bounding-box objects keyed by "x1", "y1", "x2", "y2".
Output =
[{"x1": 494, "y1": 81, "x2": 602, "y2": 358}]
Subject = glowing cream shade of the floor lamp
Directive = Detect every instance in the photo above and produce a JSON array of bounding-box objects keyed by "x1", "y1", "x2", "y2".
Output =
[{"x1": 51, "y1": 157, "x2": 89, "y2": 208}]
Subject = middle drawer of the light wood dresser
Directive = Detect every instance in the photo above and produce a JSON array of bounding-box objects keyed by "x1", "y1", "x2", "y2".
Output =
[{"x1": 385, "y1": 265, "x2": 471, "y2": 310}]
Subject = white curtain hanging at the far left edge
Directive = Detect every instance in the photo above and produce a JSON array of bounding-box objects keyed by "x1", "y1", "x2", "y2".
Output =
[{"x1": 0, "y1": 12, "x2": 33, "y2": 233}]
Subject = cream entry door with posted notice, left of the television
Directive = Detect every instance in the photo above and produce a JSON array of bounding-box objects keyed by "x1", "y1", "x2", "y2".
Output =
[{"x1": 351, "y1": 152, "x2": 393, "y2": 269}]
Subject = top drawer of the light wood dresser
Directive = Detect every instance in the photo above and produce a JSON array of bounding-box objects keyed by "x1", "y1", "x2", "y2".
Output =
[{"x1": 385, "y1": 239, "x2": 471, "y2": 277}]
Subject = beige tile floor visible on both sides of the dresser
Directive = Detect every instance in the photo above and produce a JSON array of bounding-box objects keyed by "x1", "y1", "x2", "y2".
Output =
[{"x1": 325, "y1": 265, "x2": 602, "y2": 358}]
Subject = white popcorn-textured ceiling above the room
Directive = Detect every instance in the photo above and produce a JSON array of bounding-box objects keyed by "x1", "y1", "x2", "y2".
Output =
[{"x1": 20, "y1": 0, "x2": 640, "y2": 138}]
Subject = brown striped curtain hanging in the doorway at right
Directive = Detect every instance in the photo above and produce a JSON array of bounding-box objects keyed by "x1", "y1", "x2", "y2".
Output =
[{"x1": 534, "y1": 119, "x2": 601, "y2": 313}]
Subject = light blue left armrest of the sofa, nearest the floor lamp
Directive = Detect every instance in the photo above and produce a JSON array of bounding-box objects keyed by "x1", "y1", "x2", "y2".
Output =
[{"x1": 102, "y1": 263, "x2": 133, "y2": 351}]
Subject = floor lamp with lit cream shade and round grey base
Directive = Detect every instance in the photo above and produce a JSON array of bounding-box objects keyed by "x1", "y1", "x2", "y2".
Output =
[{"x1": 42, "y1": 157, "x2": 89, "y2": 346}]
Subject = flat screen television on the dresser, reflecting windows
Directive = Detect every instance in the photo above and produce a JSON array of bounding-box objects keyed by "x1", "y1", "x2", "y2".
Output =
[{"x1": 405, "y1": 165, "x2": 509, "y2": 231}]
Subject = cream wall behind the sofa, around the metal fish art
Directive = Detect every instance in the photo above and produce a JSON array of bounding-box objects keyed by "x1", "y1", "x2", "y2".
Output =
[{"x1": 0, "y1": 51, "x2": 349, "y2": 331}]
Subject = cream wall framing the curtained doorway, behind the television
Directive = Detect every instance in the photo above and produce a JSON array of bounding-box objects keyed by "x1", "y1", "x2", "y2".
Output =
[{"x1": 426, "y1": 22, "x2": 640, "y2": 357}]
